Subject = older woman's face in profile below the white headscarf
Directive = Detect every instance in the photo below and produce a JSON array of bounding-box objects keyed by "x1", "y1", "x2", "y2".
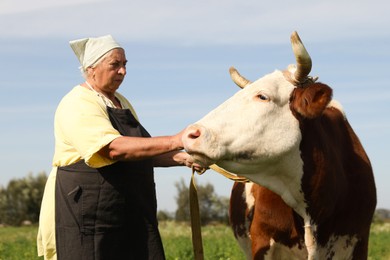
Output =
[{"x1": 92, "y1": 49, "x2": 127, "y2": 94}]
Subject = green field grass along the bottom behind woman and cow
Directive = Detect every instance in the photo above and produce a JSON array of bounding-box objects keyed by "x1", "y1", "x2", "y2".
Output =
[{"x1": 0, "y1": 222, "x2": 390, "y2": 260}]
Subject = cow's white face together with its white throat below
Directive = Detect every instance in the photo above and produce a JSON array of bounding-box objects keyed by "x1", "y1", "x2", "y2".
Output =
[{"x1": 183, "y1": 68, "x2": 306, "y2": 215}]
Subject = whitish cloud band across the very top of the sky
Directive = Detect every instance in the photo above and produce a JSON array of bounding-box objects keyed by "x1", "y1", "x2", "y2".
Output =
[{"x1": 0, "y1": 0, "x2": 390, "y2": 44}]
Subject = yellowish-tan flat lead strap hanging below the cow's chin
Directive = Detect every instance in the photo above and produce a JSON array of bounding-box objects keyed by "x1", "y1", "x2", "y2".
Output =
[{"x1": 189, "y1": 164, "x2": 249, "y2": 260}]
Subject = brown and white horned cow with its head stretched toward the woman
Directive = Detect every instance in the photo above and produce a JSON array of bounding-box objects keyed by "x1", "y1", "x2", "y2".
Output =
[{"x1": 182, "y1": 32, "x2": 376, "y2": 259}]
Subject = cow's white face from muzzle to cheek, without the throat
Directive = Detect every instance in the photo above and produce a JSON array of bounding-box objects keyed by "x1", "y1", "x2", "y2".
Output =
[{"x1": 183, "y1": 71, "x2": 301, "y2": 170}]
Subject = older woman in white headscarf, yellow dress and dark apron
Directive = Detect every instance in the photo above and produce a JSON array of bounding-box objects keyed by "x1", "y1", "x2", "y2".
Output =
[{"x1": 38, "y1": 35, "x2": 201, "y2": 260}]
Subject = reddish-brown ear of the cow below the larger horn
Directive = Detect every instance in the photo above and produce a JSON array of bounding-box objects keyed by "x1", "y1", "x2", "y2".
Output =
[{"x1": 290, "y1": 83, "x2": 332, "y2": 119}]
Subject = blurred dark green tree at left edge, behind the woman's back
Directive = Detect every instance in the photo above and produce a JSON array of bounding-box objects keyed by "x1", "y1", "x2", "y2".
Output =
[{"x1": 0, "y1": 172, "x2": 47, "y2": 225}]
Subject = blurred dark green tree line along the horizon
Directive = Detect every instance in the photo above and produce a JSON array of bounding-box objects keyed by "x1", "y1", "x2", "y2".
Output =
[{"x1": 0, "y1": 172, "x2": 229, "y2": 226}]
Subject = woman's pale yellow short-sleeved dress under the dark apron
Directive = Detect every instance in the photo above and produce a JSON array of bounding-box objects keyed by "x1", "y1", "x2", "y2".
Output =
[{"x1": 37, "y1": 85, "x2": 138, "y2": 259}]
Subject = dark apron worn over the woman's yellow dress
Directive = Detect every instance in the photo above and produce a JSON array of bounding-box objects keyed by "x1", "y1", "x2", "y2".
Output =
[{"x1": 55, "y1": 107, "x2": 165, "y2": 260}]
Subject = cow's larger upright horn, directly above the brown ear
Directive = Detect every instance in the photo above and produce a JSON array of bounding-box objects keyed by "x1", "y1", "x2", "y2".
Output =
[{"x1": 291, "y1": 31, "x2": 311, "y2": 84}]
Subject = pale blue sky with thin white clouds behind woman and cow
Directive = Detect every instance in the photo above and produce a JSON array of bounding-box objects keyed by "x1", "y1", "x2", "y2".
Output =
[{"x1": 0, "y1": 0, "x2": 390, "y2": 212}]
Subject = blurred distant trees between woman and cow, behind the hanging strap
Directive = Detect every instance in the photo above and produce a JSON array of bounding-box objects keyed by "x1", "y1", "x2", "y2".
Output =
[{"x1": 175, "y1": 179, "x2": 229, "y2": 225}]
